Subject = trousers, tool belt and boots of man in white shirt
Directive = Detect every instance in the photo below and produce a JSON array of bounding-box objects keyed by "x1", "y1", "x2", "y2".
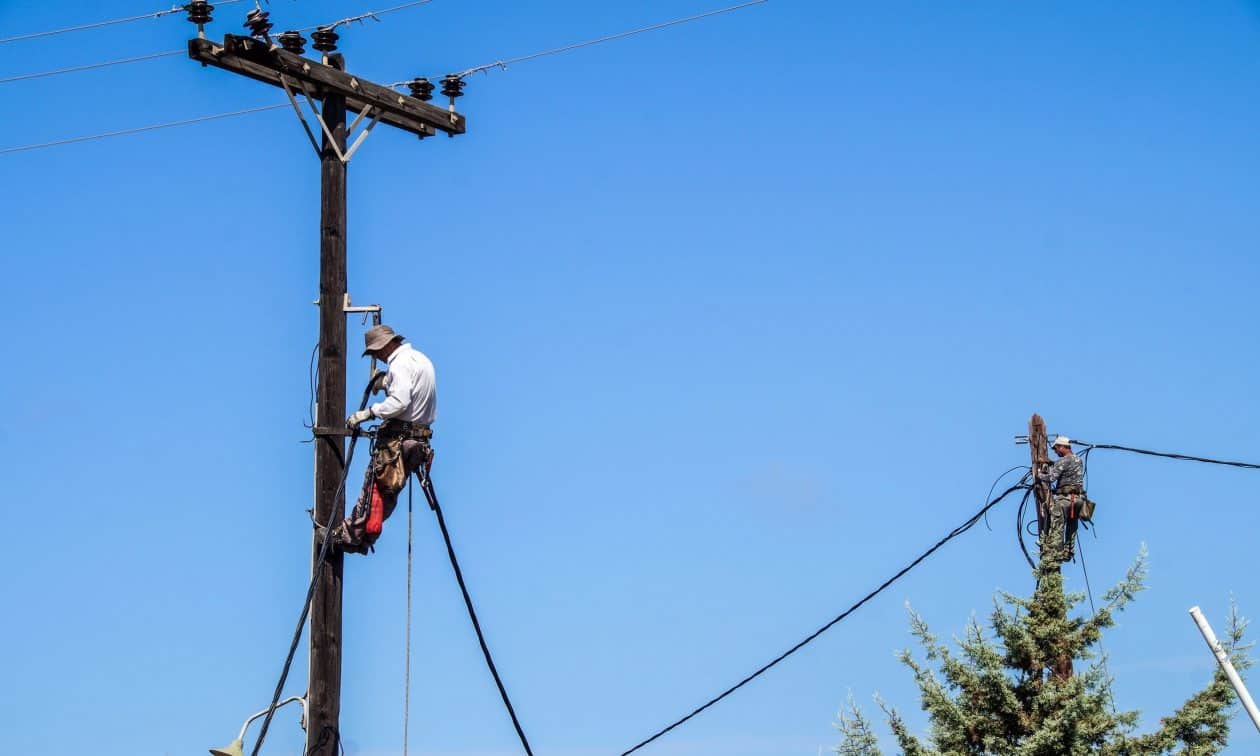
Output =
[{"x1": 334, "y1": 425, "x2": 433, "y2": 554}]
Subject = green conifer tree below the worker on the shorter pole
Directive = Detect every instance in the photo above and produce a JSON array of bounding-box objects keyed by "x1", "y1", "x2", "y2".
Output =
[{"x1": 835, "y1": 549, "x2": 1250, "y2": 756}]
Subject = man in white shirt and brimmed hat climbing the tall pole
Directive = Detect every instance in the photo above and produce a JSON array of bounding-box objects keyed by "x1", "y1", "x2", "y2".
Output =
[{"x1": 334, "y1": 325, "x2": 437, "y2": 554}]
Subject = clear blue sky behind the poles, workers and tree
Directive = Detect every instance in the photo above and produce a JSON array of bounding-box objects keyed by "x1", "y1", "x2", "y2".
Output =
[{"x1": 0, "y1": 0, "x2": 1260, "y2": 756}]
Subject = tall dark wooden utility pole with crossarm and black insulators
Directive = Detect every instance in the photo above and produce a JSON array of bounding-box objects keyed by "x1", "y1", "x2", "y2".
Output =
[{"x1": 188, "y1": 14, "x2": 465, "y2": 756}]
